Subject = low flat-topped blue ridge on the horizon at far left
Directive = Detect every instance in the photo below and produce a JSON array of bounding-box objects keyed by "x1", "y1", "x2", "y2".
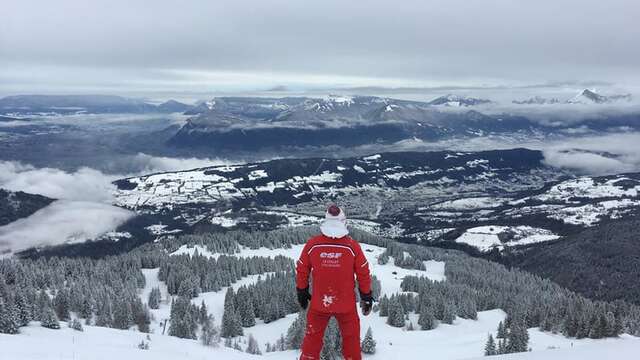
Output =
[{"x1": 0, "y1": 95, "x2": 191, "y2": 116}]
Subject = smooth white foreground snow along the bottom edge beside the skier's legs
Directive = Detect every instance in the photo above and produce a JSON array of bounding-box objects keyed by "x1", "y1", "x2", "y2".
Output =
[{"x1": 0, "y1": 310, "x2": 640, "y2": 360}]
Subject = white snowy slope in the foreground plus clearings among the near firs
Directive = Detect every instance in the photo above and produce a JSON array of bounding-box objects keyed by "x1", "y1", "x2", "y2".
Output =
[{"x1": 0, "y1": 240, "x2": 640, "y2": 360}]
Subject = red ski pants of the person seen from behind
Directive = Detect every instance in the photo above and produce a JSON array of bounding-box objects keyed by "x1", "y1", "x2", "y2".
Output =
[{"x1": 300, "y1": 307, "x2": 362, "y2": 360}]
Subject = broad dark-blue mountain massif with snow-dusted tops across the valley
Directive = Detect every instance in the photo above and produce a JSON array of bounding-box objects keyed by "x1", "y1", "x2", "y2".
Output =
[{"x1": 168, "y1": 95, "x2": 640, "y2": 153}]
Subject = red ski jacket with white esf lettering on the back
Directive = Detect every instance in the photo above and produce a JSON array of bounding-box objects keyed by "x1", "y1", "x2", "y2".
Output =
[{"x1": 296, "y1": 235, "x2": 371, "y2": 314}]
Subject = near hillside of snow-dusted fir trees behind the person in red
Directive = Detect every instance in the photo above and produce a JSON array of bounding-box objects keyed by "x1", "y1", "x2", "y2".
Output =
[{"x1": 0, "y1": 227, "x2": 640, "y2": 360}]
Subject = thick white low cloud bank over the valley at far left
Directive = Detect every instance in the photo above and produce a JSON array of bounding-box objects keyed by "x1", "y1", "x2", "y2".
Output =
[{"x1": 0, "y1": 153, "x2": 236, "y2": 254}]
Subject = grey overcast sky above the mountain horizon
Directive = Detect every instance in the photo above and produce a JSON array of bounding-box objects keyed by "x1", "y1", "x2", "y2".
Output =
[{"x1": 0, "y1": 0, "x2": 640, "y2": 95}]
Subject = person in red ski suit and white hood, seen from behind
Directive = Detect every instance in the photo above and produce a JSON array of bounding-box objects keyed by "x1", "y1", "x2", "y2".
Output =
[{"x1": 296, "y1": 205, "x2": 373, "y2": 360}]
